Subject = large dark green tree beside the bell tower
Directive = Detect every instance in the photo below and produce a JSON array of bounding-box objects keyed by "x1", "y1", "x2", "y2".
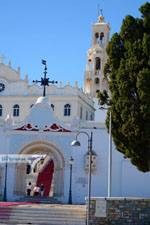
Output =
[{"x1": 98, "y1": 2, "x2": 150, "y2": 172}]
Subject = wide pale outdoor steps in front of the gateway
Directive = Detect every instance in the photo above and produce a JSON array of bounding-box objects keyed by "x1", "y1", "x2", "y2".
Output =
[{"x1": 0, "y1": 204, "x2": 85, "y2": 225}]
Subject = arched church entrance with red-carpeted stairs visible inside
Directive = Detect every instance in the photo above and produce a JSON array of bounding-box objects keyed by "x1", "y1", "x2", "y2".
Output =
[{"x1": 14, "y1": 141, "x2": 65, "y2": 197}]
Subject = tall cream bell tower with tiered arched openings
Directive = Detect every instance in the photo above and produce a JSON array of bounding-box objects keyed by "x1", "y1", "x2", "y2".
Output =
[{"x1": 84, "y1": 10, "x2": 110, "y2": 98}]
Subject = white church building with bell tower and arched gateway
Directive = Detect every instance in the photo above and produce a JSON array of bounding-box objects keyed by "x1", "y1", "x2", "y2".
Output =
[{"x1": 0, "y1": 11, "x2": 150, "y2": 204}]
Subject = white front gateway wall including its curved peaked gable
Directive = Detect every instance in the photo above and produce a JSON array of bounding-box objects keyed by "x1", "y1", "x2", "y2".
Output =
[{"x1": 0, "y1": 98, "x2": 150, "y2": 204}]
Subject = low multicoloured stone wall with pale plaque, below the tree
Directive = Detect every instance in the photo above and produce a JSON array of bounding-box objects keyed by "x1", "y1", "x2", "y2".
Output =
[{"x1": 86, "y1": 197, "x2": 150, "y2": 225}]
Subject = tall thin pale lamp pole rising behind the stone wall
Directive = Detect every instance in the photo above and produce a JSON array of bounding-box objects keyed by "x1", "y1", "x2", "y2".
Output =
[{"x1": 99, "y1": 107, "x2": 112, "y2": 197}]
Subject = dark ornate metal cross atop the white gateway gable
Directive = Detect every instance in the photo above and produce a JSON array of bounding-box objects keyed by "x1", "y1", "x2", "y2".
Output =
[{"x1": 33, "y1": 59, "x2": 58, "y2": 97}]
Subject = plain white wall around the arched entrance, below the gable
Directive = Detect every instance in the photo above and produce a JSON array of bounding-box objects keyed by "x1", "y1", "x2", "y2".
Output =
[{"x1": 0, "y1": 118, "x2": 150, "y2": 204}]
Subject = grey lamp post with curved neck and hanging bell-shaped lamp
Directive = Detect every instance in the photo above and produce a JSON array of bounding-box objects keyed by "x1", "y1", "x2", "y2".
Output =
[{"x1": 71, "y1": 131, "x2": 93, "y2": 225}]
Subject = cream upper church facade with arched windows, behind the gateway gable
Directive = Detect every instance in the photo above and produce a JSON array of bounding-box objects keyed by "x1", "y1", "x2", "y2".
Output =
[{"x1": 0, "y1": 62, "x2": 95, "y2": 123}]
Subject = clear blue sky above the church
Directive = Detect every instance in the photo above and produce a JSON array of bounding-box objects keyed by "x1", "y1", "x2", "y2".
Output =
[{"x1": 0, "y1": 0, "x2": 146, "y2": 87}]
